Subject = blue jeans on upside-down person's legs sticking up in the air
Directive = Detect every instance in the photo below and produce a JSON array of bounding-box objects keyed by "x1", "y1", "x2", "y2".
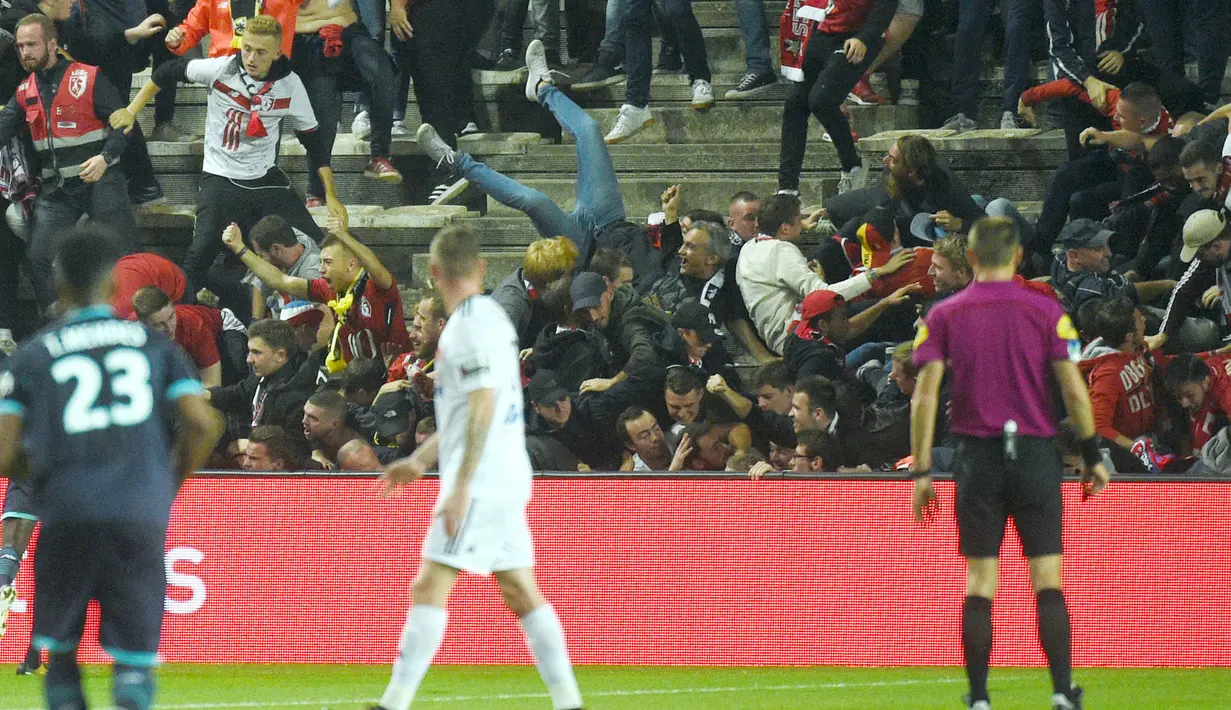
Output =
[{"x1": 457, "y1": 86, "x2": 624, "y2": 258}]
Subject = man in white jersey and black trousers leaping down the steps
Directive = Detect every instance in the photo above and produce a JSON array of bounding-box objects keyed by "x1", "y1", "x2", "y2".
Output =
[{"x1": 111, "y1": 15, "x2": 342, "y2": 320}]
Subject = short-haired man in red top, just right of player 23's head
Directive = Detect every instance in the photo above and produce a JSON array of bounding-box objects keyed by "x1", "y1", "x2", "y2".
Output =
[{"x1": 130, "y1": 285, "x2": 247, "y2": 388}]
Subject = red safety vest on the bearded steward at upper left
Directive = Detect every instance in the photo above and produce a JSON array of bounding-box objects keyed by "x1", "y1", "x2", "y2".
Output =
[{"x1": 17, "y1": 62, "x2": 107, "y2": 180}]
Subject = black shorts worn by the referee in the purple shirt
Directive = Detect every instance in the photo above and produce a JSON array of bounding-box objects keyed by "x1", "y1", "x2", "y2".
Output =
[{"x1": 953, "y1": 436, "x2": 1064, "y2": 557}]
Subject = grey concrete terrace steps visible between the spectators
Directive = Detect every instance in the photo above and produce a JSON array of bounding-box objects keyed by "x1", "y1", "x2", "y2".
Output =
[{"x1": 124, "y1": 0, "x2": 1132, "y2": 301}]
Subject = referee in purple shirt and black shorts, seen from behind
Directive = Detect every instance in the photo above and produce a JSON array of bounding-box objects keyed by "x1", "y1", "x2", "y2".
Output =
[{"x1": 911, "y1": 217, "x2": 1109, "y2": 710}]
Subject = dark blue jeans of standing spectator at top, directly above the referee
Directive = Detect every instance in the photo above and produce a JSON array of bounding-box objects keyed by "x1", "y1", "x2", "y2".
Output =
[{"x1": 953, "y1": 0, "x2": 1043, "y2": 118}]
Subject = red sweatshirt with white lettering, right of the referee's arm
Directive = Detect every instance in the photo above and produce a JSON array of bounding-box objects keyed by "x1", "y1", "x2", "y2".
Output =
[{"x1": 1081, "y1": 349, "x2": 1158, "y2": 441}]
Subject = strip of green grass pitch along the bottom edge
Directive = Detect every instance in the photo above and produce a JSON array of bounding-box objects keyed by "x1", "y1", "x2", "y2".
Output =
[{"x1": 0, "y1": 666, "x2": 1231, "y2": 710}]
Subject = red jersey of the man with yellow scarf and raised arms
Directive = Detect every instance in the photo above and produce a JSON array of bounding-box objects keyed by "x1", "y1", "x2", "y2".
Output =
[{"x1": 308, "y1": 274, "x2": 410, "y2": 362}]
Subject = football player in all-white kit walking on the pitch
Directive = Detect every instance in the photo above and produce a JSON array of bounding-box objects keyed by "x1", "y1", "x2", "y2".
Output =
[{"x1": 373, "y1": 226, "x2": 581, "y2": 710}]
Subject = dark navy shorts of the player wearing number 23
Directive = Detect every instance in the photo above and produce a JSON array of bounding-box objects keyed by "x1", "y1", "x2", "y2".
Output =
[{"x1": 33, "y1": 523, "x2": 166, "y2": 668}]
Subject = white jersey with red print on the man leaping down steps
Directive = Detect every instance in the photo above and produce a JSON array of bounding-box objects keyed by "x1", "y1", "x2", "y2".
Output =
[{"x1": 185, "y1": 54, "x2": 316, "y2": 180}]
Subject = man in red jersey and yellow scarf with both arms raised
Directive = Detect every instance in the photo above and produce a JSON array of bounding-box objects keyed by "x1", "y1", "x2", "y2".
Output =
[{"x1": 223, "y1": 209, "x2": 410, "y2": 372}]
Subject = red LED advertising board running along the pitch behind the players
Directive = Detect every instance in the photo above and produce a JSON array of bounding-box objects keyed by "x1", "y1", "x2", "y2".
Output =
[{"x1": 0, "y1": 477, "x2": 1231, "y2": 666}]
